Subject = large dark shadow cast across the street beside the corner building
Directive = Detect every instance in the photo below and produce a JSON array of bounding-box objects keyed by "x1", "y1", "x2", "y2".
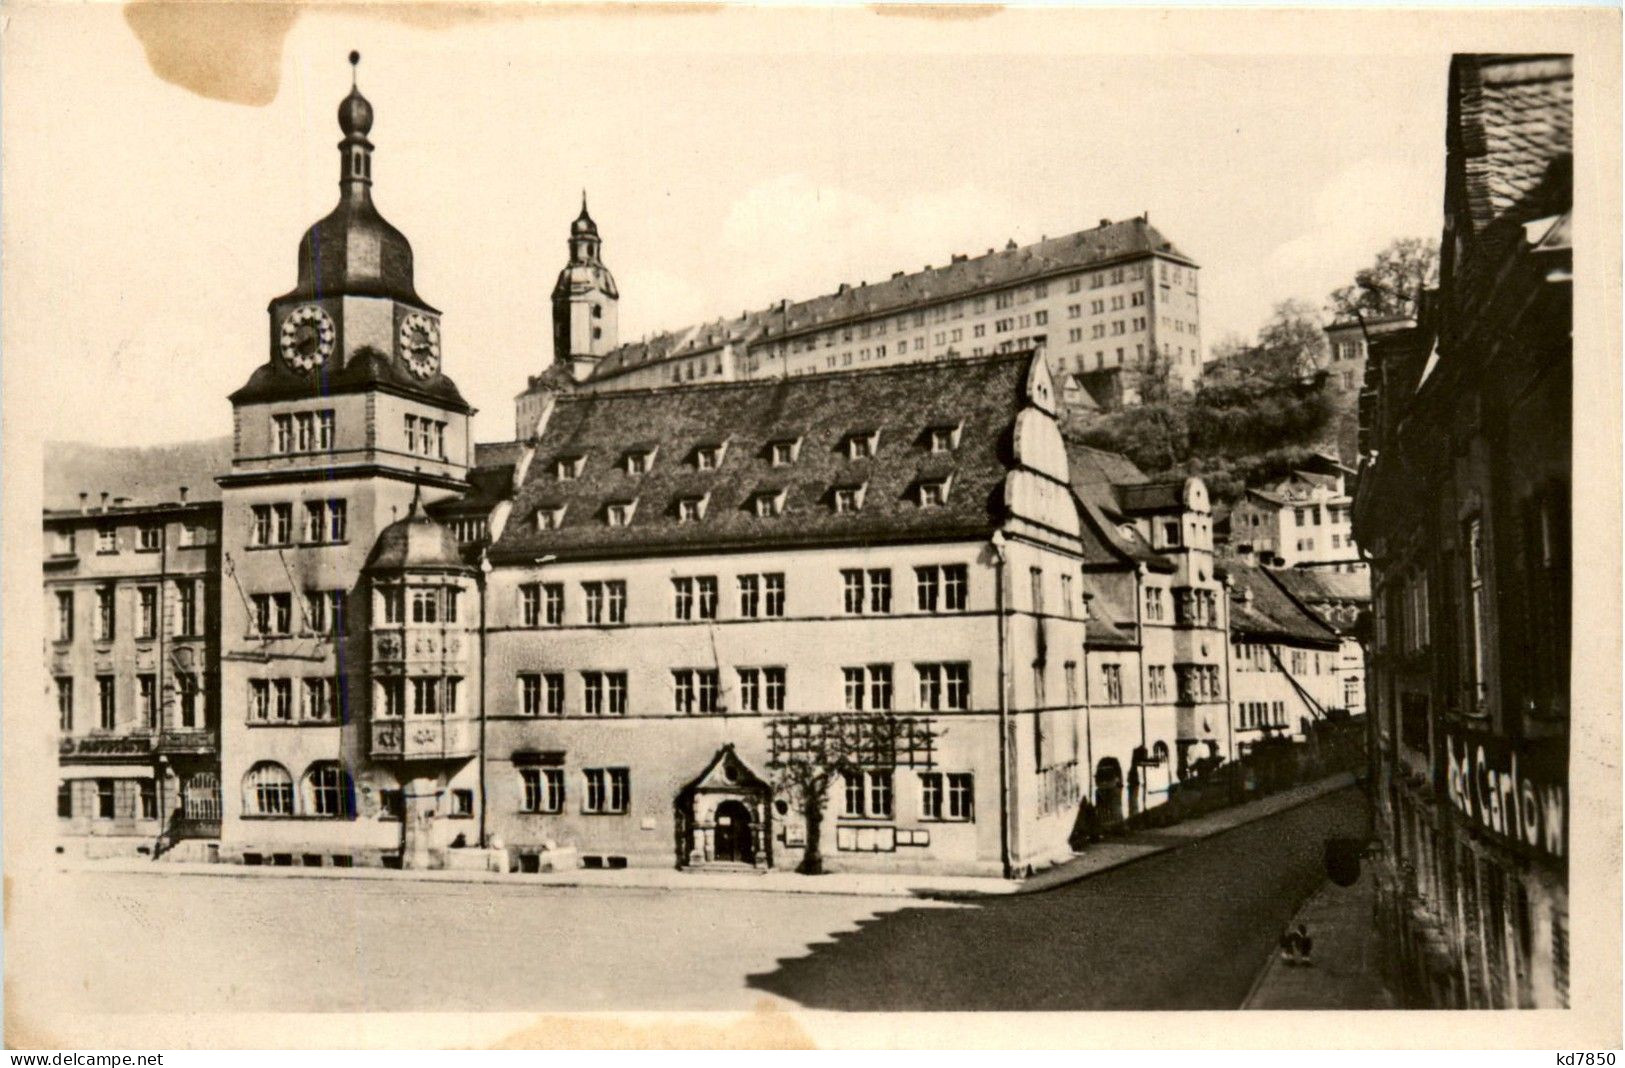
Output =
[{"x1": 748, "y1": 787, "x2": 1367, "y2": 1011}]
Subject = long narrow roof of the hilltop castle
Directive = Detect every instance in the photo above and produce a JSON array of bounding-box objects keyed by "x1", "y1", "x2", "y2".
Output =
[{"x1": 593, "y1": 218, "x2": 1196, "y2": 379}]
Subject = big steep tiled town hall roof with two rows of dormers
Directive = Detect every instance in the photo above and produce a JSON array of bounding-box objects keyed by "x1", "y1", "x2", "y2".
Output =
[{"x1": 492, "y1": 353, "x2": 1032, "y2": 559}]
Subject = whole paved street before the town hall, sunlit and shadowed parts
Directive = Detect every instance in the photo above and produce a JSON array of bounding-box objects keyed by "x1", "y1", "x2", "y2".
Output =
[{"x1": 20, "y1": 790, "x2": 1365, "y2": 1011}]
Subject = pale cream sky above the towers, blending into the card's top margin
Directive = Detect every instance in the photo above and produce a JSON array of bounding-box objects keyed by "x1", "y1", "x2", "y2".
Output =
[{"x1": 5, "y1": 5, "x2": 1448, "y2": 444}]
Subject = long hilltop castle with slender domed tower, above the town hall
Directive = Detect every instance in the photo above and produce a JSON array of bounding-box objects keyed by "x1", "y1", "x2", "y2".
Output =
[{"x1": 515, "y1": 209, "x2": 1204, "y2": 441}]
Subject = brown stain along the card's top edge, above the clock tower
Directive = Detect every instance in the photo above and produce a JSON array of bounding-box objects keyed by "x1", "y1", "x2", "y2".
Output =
[{"x1": 124, "y1": 0, "x2": 726, "y2": 107}]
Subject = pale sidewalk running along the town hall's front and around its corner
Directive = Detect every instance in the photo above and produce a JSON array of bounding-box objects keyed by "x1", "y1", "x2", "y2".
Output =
[{"x1": 63, "y1": 774, "x2": 1354, "y2": 897}]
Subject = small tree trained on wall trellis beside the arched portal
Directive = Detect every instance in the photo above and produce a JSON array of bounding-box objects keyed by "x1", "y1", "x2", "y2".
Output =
[{"x1": 767, "y1": 712, "x2": 941, "y2": 875}]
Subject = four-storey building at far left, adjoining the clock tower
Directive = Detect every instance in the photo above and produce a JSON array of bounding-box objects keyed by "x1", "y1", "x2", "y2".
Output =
[{"x1": 46, "y1": 488, "x2": 221, "y2": 857}]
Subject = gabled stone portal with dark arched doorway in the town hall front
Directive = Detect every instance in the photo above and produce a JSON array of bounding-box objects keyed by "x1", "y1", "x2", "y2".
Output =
[{"x1": 678, "y1": 745, "x2": 774, "y2": 868}]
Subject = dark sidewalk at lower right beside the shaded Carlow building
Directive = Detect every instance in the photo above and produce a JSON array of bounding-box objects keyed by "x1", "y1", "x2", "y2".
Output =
[{"x1": 1242, "y1": 863, "x2": 1394, "y2": 1009}]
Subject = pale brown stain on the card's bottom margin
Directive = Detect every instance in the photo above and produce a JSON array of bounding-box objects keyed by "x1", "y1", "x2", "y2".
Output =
[{"x1": 489, "y1": 1000, "x2": 817, "y2": 1050}]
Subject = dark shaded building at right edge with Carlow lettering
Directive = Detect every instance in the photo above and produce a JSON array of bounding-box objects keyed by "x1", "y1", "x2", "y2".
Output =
[{"x1": 1354, "y1": 55, "x2": 1566, "y2": 1008}]
